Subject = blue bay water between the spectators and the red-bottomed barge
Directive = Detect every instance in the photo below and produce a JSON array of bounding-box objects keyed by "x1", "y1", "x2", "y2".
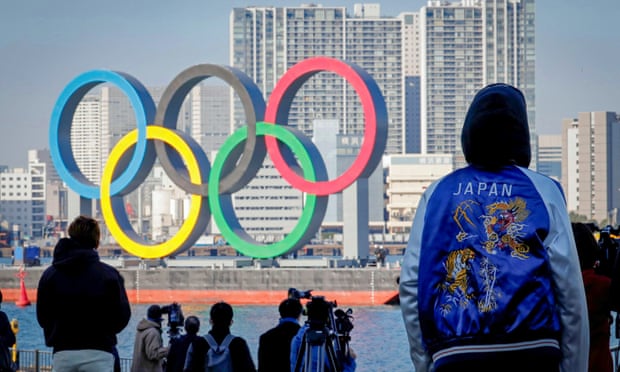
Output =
[{"x1": 2, "y1": 299, "x2": 413, "y2": 372}]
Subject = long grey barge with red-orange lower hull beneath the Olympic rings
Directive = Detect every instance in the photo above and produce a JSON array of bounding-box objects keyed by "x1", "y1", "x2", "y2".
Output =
[{"x1": 0, "y1": 268, "x2": 400, "y2": 305}]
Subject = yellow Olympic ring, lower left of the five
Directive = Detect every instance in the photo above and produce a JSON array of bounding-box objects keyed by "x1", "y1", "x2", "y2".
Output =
[{"x1": 100, "y1": 125, "x2": 207, "y2": 258}]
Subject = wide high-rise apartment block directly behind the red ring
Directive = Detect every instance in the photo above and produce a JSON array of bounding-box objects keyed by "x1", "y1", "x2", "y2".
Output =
[{"x1": 230, "y1": 4, "x2": 404, "y2": 153}]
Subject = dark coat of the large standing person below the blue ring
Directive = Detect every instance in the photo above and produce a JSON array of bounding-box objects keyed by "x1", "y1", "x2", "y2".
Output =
[{"x1": 37, "y1": 238, "x2": 131, "y2": 353}]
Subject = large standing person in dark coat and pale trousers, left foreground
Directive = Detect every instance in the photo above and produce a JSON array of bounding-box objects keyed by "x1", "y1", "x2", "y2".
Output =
[{"x1": 37, "y1": 216, "x2": 131, "y2": 372}]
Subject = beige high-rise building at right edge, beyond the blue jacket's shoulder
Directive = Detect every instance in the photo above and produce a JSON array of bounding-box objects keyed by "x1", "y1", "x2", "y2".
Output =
[{"x1": 562, "y1": 111, "x2": 620, "y2": 226}]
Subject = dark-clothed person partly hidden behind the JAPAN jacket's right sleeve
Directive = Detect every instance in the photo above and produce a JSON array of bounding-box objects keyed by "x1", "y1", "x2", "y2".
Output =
[{"x1": 572, "y1": 223, "x2": 613, "y2": 372}]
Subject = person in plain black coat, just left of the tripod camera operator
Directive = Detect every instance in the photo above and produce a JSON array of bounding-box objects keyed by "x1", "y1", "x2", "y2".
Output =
[{"x1": 258, "y1": 298, "x2": 302, "y2": 372}]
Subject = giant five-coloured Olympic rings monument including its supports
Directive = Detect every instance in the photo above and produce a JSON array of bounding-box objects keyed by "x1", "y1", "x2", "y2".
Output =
[{"x1": 49, "y1": 57, "x2": 388, "y2": 258}]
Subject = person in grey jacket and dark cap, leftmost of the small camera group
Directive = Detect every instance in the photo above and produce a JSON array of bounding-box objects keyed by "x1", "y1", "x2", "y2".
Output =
[{"x1": 131, "y1": 305, "x2": 168, "y2": 372}]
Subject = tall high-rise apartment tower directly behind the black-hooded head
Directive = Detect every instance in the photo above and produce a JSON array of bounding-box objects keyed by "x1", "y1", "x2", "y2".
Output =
[{"x1": 420, "y1": 0, "x2": 536, "y2": 167}]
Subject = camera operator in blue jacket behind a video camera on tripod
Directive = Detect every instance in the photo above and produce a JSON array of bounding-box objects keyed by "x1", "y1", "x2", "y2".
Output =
[{"x1": 290, "y1": 296, "x2": 356, "y2": 372}]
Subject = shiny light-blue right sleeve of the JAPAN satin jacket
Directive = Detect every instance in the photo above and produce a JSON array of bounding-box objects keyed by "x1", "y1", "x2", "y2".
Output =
[{"x1": 543, "y1": 185, "x2": 590, "y2": 372}]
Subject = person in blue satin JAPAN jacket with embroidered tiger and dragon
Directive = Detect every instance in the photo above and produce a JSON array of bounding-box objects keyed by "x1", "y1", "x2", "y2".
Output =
[{"x1": 399, "y1": 84, "x2": 589, "y2": 372}]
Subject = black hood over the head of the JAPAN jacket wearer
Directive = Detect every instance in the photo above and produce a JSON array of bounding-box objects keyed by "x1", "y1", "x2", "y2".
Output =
[{"x1": 461, "y1": 84, "x2": 532, "y2": 168}]
